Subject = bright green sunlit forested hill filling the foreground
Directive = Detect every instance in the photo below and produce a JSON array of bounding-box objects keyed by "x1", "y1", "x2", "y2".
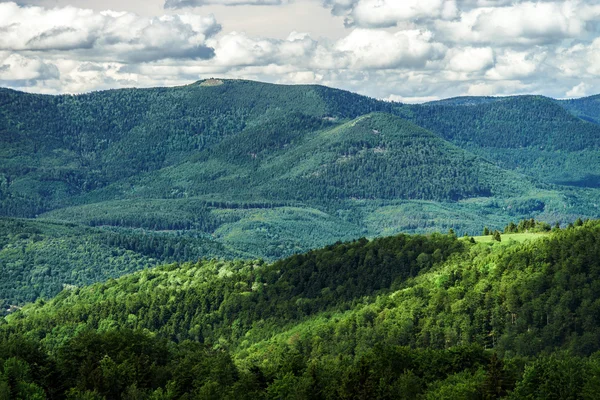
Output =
[{"x1": 0, "y1": 221, "x2": 600, "y2": 399}]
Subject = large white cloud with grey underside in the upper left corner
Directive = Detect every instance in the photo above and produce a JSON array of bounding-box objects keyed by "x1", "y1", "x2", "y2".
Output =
[{"x1": 0, "y1": 3, "x2": 221, "y2": 62}]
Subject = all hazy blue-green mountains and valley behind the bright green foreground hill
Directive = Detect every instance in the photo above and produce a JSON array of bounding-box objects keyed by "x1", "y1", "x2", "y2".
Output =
[{"x1": 0, "y1": 79, "x2": 600, "y2": 303}]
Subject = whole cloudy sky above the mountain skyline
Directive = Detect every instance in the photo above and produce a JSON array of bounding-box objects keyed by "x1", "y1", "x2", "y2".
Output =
[{"x1": 0, "y1": 0, "x2": 600, "y2": 103}]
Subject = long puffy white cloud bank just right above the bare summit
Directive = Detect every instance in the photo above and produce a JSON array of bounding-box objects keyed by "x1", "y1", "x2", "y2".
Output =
[{"x1": 210, "y1": 29, "x2": 445, "y2": 70}]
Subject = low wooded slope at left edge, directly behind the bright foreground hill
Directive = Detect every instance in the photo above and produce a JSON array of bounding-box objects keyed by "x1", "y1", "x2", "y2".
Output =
[{"x1": 0, "y1": 218, "x2": 244, "y2": 311}]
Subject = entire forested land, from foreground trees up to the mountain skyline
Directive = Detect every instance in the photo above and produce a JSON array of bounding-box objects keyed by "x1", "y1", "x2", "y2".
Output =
[{"x1": 0, "y1": 80, "x2": 600, "y2": 400}]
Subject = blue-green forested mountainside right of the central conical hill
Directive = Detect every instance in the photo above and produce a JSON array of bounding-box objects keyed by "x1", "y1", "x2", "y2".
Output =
[{"x1": 408, "y1": 96, "x2": 600, "y2": 188}]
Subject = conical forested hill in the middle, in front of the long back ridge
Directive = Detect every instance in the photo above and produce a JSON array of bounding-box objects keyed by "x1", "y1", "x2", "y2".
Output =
[{"x1": 85, "y1": 113, "x2": 533, "y2": 206}]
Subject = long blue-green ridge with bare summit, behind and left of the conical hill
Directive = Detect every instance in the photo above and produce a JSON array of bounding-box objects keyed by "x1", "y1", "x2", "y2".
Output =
[{"x1": 0, "y1": 81, "x2": 391, "y2": 216}]
